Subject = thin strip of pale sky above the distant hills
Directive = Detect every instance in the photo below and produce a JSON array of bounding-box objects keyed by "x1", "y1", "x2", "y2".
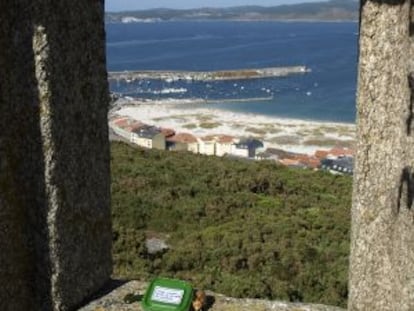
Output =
[{"x1": 105, "y1": 0, "x2": 322, "y2": 11}]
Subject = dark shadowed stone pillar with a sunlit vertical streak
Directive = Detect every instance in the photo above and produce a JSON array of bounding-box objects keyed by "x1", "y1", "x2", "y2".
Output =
[{"x1": 0, "y1": 0, "x2": 112, "y2": 310}]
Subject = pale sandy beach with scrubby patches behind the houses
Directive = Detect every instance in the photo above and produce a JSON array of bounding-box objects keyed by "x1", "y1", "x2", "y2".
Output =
[{"x1": 112, "y1": 100, "x2": 355, "y2": 154}]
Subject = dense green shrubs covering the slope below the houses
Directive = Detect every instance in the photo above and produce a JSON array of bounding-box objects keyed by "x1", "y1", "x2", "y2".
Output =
[{"x1": 112, "y1": 143, "x2": 351, "y2": 306}]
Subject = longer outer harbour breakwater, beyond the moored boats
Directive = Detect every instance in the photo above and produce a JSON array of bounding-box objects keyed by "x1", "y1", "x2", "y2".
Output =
[{"x1": 108, "y1": 66, "x2": 311, "y2": 82}]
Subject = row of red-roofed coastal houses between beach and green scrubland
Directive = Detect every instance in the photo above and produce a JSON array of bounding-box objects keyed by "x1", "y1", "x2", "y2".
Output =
[{"x1": 109, "y1": 99, "x2": 354, "y2": 175}]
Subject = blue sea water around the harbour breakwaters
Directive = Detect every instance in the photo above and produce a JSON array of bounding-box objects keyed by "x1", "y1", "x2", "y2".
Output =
[{"x1": 106, "y1": 22, "x2": 358, "y2": 123}]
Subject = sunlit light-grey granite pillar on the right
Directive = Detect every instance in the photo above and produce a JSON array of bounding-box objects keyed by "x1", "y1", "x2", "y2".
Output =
[{"x1": 349, "y1": 0, "x2": 414, "y2": 311}]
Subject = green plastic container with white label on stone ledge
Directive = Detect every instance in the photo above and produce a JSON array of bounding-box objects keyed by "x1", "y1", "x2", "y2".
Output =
[{"x1": 141, "y1": 278, "x2": 193, "y2": 311}]
